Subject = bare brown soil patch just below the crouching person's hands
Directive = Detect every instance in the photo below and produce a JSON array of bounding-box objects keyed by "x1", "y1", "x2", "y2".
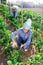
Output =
[{"x1": 20, "y1": 45, "x2": 36, "y2": 62}]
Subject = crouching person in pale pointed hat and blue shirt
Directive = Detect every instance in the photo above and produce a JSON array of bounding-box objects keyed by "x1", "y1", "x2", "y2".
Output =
[{"x1": 11, "y1": 19, "x2": 32, "y2": 51}]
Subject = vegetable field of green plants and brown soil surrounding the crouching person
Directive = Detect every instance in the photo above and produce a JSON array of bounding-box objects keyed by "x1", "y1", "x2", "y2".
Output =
[{"x1": 0, "y1": 4, "x2": 43, "y2": 65}]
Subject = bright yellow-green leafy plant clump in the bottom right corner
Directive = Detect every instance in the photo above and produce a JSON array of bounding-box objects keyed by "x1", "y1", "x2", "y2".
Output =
[{"x1": 27, "y1": 53, "x2": 41, "y2": 65}]
